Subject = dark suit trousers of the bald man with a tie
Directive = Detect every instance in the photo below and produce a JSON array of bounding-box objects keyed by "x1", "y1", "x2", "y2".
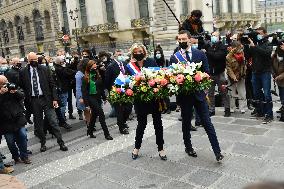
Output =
[{"x1": 31, "y1": 98, "x2": 64, "y2": 144}]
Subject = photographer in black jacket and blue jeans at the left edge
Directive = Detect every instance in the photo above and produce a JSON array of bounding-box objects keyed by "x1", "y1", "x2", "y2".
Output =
[{"x1": 0, "y1": 75, "x2": 31, "y2": 164}]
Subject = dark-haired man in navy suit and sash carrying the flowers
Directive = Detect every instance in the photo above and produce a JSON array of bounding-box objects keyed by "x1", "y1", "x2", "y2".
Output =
[{"x1": 171, "y1": 30, "x2": 224, "y2": 161}]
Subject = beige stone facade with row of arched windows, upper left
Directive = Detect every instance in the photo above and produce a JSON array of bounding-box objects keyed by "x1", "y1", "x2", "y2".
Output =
[{"x1": 0, "y1": 0, "x2": 60, "y2": 57}]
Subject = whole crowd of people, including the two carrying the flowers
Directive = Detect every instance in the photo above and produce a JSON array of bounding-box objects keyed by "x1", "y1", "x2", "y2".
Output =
[{"x1": 0, "y1": 11, "x2": 284, "y2": 176}]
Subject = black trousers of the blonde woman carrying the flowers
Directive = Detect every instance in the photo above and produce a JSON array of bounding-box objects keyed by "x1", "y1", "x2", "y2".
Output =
[{"x1": 135, "y1": 112, "x2": 164, "y2": 151}]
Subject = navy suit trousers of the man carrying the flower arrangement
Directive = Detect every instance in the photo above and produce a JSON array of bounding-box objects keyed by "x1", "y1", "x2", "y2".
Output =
[{"x1": 180, "y1": 94, "x2": 221, "y2": 154}]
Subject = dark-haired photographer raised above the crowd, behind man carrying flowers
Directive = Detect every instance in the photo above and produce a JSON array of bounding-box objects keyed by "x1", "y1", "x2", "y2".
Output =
[{"x1": 179, "y1": 10, "x2": 204, "y2": 36}]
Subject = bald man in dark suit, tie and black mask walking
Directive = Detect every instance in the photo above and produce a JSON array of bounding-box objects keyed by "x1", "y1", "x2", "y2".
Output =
[{"x1": 19, "y1": 52, "x2": 68, "y2": 152}]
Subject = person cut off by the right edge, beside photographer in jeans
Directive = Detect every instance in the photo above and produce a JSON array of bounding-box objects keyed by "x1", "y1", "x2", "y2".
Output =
[{"x1": 272, "y1": 42, "x2": 284, "y2": 121}]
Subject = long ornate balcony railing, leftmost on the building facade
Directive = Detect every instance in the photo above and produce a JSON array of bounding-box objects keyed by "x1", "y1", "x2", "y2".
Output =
[{"x1": 72, "y1": 22, "x2": 118, "y2": 35}]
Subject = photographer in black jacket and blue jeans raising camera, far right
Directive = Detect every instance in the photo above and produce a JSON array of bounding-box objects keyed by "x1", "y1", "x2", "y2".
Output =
[{"x1": 249, "y1": 27, "x2": 273, "y2": 124}]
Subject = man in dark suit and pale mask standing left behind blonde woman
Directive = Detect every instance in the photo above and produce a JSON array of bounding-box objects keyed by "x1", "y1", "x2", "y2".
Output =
[{"x1": 105, "y1": 50, "x2": 132, "y2": 134}]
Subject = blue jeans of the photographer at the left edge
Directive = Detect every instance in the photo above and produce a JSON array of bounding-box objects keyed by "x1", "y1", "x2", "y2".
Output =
[{"x1": 4, "y1": 127, "x2": 28, "y2": 160}]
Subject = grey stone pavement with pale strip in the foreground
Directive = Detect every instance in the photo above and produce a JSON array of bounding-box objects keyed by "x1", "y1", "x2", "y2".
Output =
[{"x1": 0, "y1": 105, "x2": 284, "y2": 189}]
